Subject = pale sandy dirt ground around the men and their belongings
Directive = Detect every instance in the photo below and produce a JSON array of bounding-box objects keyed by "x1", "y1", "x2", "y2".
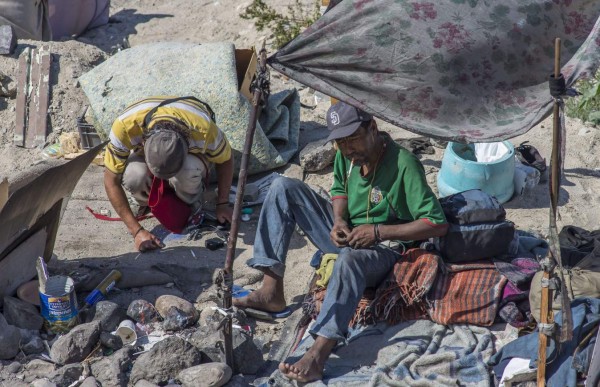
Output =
[{"x1": 0, "y1": 0, "x2": 600, "y2": 382}]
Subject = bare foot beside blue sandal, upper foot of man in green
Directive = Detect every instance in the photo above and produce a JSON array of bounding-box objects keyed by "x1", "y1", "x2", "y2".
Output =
[{"x1": 233, "y1": 270, "x2": 286, "y2": 312}]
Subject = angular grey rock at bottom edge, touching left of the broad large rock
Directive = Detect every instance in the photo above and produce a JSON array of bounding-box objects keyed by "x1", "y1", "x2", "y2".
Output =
[{"x1": 91, "y1": 347, "x2": 135, "y2": 387}]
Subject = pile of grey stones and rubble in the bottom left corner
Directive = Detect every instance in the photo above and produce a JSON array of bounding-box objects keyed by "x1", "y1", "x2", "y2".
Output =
[{"x1": 0, "y1": 295, "x2": 262, "y2": 387}]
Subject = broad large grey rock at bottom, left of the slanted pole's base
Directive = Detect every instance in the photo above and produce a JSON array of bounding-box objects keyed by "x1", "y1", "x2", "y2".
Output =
[{"x1": 130, "y1": 336, "x2": 202, "y2": 384}]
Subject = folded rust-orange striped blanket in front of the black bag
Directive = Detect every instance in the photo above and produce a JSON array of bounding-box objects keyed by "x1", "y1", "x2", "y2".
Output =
[{"x1": 428, "y1": 262, "x2": 507, "y2": 326}]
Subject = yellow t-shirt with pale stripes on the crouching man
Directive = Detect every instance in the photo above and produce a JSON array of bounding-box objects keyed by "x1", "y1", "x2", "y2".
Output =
[{"x1": 104, "y1": 97, "x2": 231, "y2": 174}]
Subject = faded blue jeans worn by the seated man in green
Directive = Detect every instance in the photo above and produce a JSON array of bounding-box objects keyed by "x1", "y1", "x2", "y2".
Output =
[{"x1": 248, "y1": 177, "x2": 400, "y2": 341}]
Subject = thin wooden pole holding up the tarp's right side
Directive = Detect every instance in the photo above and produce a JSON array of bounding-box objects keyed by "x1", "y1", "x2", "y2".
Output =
[{"x1": 537, "y1": 38, "x2": 560, "y2": 387}]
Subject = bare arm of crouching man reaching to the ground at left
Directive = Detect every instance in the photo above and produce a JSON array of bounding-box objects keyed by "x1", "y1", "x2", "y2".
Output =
[{"x1": 104, "y1": 168, "x2": 162, "y2": 251}]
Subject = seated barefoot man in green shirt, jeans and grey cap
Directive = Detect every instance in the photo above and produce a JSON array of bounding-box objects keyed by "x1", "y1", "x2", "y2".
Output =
[{"x1": 234, "y1": 103, "x2": 447, "y2": 382}]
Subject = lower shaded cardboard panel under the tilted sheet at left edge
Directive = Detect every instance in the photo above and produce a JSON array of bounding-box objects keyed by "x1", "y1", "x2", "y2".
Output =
[{"x1": 0, "y1": 229, "x2": 48, "y2": 305}]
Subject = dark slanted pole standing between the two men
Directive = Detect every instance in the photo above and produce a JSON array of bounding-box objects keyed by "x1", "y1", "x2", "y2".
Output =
[{"x1": 223, "y1": 42, "x2": 267, "y2": 371}]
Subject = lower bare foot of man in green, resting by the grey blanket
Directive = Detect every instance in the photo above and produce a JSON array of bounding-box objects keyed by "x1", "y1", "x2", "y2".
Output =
[{"x1": 279, "y1": 336, "x2": 337, "y2": 383}]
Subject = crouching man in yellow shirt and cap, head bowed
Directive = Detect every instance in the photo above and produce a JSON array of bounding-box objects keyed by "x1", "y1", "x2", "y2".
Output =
[{"x1": 104, "y1": 97, "x2": 233, "y2": 251}]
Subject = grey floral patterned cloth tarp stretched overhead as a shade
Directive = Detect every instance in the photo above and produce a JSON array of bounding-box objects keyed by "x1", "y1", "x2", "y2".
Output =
[{"x1": 269, "y1": 0, "x2": 600, "y2": 142}]
